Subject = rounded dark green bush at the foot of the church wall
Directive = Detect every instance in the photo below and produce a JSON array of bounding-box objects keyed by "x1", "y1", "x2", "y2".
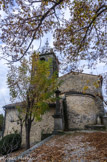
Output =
[{"x1": 0, "y1": 133, "x2": 21, "y2": 155}]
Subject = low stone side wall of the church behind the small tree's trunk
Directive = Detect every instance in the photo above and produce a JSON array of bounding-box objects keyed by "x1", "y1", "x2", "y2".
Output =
[{"x1": 4, "y1": 108, "x2": 55, "y2": 145}]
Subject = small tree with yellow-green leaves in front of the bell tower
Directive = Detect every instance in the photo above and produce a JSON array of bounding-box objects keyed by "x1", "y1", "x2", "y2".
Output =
[{"x1": 7, "y1": 52, "x2": 58, "y2": 149}]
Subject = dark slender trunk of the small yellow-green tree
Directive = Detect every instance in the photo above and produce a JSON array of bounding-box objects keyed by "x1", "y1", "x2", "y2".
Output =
[{"x1": 25, "y1": 119, "x2": 32, "y2": 150}]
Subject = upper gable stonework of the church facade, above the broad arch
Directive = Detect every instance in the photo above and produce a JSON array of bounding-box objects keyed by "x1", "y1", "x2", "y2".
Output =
[{"x1": 59, "y1": 73, "x2": 102, "y2": 95}]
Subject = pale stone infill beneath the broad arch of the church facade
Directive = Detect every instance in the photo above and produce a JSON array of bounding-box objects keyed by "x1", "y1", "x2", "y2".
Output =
[{"x1": 66, "y1": 95, "x2": 98, "y2": 129}]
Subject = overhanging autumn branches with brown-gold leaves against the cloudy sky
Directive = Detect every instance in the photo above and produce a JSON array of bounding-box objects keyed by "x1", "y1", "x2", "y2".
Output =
[{"x1": 0, "y1": 0, "x2": 107, "y2": 68}]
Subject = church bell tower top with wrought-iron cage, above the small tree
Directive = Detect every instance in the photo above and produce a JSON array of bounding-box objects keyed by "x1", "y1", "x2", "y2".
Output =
[{"x1": 39, "y1": 40, "x2": 59, "y2": 75}]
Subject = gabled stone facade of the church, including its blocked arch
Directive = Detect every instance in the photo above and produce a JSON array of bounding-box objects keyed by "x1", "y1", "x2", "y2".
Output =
[{"x1": 59, "y1": 73, "x2": 104, "y2": 129}]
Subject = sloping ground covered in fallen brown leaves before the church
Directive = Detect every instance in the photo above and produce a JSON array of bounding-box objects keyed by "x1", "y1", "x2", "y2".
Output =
[{"x1": 2, "y1": 132, "x2": 107, "y2": 162}]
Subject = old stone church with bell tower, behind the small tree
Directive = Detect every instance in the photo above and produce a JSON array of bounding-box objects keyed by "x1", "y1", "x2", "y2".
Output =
[{"x1": 3, "y1": 50, "x2": 104, "y2": 145}]
